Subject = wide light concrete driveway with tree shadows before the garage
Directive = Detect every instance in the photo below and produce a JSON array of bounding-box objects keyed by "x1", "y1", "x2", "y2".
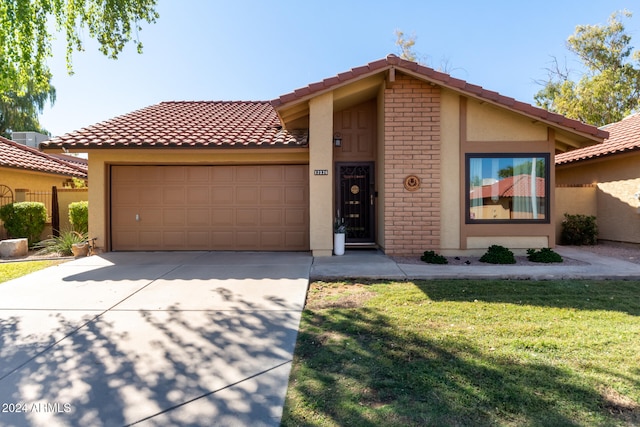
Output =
[{"x1": 0, "y1": 252, "x2": 312, "y2": 426}]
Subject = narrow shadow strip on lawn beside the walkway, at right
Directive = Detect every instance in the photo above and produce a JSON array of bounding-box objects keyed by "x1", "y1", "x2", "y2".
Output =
[{"x1": 415, "y1": 280, "x2": 640, "y2": 316}]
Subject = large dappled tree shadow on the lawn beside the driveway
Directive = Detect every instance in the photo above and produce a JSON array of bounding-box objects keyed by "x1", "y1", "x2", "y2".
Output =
[{"x1": 283, "y1": 308, "x2": 640, "y2": 426}]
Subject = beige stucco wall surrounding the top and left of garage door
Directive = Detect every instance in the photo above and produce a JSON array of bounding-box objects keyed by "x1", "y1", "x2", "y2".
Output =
[{"x1": 88, "y1": 148, "x2": 309, "y2": 250}]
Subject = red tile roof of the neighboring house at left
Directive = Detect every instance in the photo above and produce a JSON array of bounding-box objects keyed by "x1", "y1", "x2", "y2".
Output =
[{"x1": 0, "y1": 137, "x2": 87, "y2": 178}]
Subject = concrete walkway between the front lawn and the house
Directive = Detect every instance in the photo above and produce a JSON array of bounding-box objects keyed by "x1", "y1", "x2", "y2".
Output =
[{"x1": 310, "y1": 247, "x2": 640, "y2": 280}]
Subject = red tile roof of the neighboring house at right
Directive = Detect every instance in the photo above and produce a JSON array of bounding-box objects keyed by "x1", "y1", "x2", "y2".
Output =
[{"x1": 556, "y1": 113, "x2": 640, "y2": 165}]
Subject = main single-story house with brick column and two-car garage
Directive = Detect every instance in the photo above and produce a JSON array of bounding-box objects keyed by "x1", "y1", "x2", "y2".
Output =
[{"x1": 41, "y1": 55, "x2": 608, "y2": 256}]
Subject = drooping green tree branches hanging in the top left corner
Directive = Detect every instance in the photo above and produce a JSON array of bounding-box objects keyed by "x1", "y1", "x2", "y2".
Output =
[{"x1": 0, "y1": 0, "x2": 159, "y2": 132}]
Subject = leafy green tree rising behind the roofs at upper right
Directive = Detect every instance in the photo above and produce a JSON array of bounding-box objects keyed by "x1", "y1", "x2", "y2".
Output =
[{"x1": 534, "y1": 11, "x2": 640, "y2": 126}]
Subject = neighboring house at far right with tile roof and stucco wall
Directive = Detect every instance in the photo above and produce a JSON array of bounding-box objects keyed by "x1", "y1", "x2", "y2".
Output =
[{"x1": 556, "y1": 114, "x2": 640, "y2": 243}]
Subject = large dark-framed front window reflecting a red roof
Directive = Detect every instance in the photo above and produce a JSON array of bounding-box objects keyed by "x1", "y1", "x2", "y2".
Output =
[{"x1": 466, "y1": 153, "x2": 549, "y2": 223}]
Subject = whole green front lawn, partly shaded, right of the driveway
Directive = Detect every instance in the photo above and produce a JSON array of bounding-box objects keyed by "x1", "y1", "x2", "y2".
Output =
[{"x1": 282, "y1": 280, "x2": 640, "y2": 426}]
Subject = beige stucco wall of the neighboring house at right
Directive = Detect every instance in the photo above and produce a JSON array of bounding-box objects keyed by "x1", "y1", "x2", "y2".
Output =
[{"x1": 556, "y1": 153, "x2": 640, "y2": 243}]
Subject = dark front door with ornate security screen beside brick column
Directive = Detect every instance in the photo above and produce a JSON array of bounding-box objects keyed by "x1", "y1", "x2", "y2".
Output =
[{"x1": 336, "y1": 162, "x2": 375, "y2": 244}]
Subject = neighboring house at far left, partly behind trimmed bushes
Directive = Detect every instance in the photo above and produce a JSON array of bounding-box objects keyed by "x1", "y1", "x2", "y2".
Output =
[{"x1": 0, "y1": 137, "x2": 88, "y2": 238}]
